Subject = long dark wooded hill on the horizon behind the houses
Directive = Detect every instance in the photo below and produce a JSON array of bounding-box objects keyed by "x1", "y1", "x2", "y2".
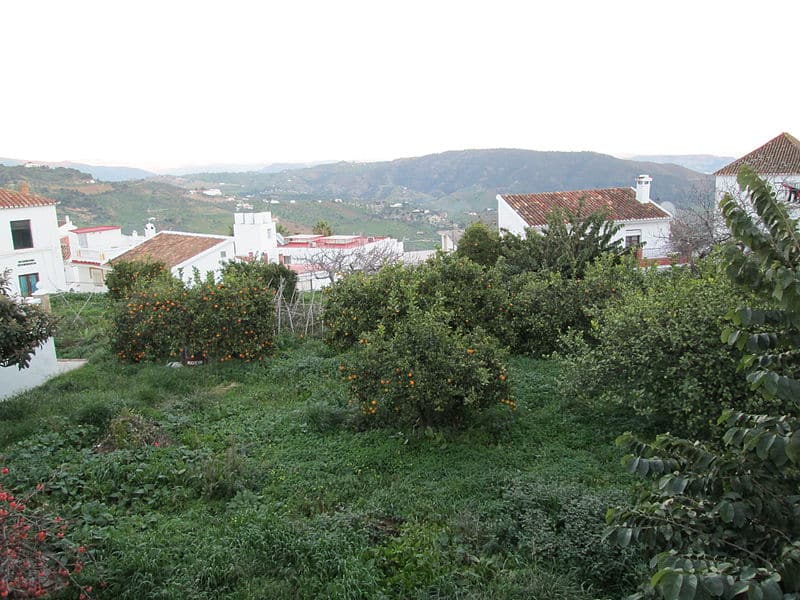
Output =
[{"x1": 191, "y1": 149, "x2": 710, "y2": 211}]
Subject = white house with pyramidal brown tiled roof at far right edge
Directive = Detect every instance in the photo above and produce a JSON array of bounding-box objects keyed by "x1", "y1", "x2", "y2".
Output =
[{"x1": 714, "y1": 133, "x2": 800, "y2": 213}]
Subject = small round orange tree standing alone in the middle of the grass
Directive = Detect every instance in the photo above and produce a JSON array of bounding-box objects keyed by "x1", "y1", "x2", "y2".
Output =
[{"x1": 341, "y1": 312, "x2": 515, "y2": 427}]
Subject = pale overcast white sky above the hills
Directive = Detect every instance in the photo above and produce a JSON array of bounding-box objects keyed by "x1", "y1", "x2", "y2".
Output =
[{"x1": 0, "y1": 0, "x2": 800, "y2": 168}]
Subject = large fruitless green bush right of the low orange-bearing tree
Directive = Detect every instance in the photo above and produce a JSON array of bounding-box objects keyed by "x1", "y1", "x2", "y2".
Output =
[{"x1": 562, "y1": 264, "x2": 764, "y2": 435}]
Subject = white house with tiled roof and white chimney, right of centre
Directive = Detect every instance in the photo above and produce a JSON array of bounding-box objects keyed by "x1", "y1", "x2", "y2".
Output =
[{"x1": 497, "y1": 175, "x2": 672, "y2": 259}]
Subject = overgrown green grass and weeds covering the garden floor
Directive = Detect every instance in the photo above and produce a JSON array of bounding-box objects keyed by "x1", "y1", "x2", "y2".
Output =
[{"x1": 0, "y1": 316, "x2": 639, "y2": 599}]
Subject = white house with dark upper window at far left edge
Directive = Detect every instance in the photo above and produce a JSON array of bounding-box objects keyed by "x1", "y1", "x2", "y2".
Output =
[{"x1": 0, "y1": 183, "x2": 67, "y2": 296}]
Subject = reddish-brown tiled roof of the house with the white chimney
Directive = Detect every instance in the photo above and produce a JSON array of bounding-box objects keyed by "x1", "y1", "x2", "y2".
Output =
[{"x1": 500, "y1": 188, "x2": 670, "y2": 227}]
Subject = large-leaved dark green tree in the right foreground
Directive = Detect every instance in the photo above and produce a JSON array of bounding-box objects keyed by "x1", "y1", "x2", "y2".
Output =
[{"x1": 607, "y1": 167, "x2": 800, "y2": 600}]
